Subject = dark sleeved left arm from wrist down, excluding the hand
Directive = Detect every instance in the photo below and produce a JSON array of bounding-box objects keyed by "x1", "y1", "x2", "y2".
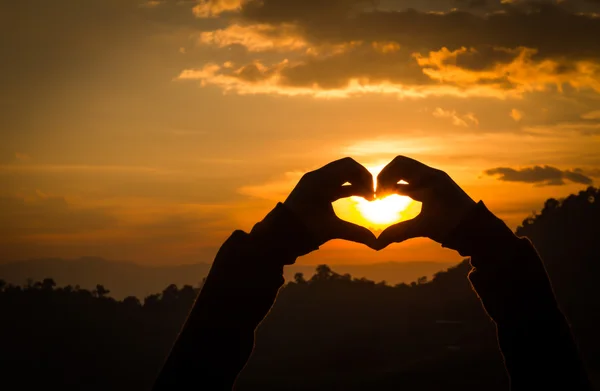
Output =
[{"x1": 153, "y1": 204, "x2": 318, "y2": 391}]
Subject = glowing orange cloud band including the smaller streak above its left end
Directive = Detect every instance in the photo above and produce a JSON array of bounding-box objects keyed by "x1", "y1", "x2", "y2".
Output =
[{"x1": 178, "y1": 41, "x2": 600, "y2": 99}]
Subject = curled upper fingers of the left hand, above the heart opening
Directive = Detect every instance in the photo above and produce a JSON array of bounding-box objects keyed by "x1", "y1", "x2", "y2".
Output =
[{"x1": 319, "y1": 157, "x2": 374, "y2": 193}]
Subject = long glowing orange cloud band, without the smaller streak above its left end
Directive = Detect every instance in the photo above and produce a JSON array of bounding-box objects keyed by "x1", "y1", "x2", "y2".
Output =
[{"x1": 177, "y1": 43, "x2": 576, "y2": 99}]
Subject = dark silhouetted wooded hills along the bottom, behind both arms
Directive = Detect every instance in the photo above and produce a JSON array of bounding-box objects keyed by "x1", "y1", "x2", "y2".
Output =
[{"x1": 0, "y1": 188, "x2": 600, "y2": 391}]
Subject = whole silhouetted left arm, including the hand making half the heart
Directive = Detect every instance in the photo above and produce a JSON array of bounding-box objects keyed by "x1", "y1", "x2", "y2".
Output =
[{"x1": 154, "y1": 158, "x2": 377, "y2": 391}]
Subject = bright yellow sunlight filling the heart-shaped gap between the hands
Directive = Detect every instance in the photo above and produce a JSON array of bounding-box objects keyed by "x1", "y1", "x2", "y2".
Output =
[{"x1": 333, "y1": 165, "x2": 421, "y2": 232}]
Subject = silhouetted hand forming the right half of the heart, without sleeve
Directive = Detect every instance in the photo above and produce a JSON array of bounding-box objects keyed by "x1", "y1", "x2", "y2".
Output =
[{"x1": 376, "y1": 156, "x2": 476, "y2": 250}]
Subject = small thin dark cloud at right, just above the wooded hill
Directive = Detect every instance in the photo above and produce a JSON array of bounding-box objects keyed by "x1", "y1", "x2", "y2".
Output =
[{"x1": 485, "y1": 166, "x2": 594, "y2": 186}]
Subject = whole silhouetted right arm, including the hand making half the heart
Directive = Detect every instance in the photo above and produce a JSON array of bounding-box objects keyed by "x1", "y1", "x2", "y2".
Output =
[{"x1": 377, "y1": 156, "x2": 591, "y2": 391}]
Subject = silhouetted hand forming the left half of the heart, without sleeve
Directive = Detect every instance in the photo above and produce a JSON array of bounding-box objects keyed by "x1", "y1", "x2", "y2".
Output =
[{"x1": 284, "y1": 158, "x2": 377, "y2": 248}]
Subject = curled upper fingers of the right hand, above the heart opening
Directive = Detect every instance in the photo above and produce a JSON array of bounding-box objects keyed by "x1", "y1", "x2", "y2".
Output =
[{"x1": 377, "y1": 156, "x2": 438, "y2": 191}]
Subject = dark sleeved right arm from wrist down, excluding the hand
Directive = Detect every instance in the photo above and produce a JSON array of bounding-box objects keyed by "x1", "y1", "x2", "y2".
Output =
[{"x1": 443, "y1": 202, "x2": 591, "y2": 391}]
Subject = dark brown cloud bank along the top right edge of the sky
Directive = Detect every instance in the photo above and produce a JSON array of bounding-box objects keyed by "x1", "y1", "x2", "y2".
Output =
[{"x1": 232, "y1": 0, "x2": 600, "y2": 58}]
